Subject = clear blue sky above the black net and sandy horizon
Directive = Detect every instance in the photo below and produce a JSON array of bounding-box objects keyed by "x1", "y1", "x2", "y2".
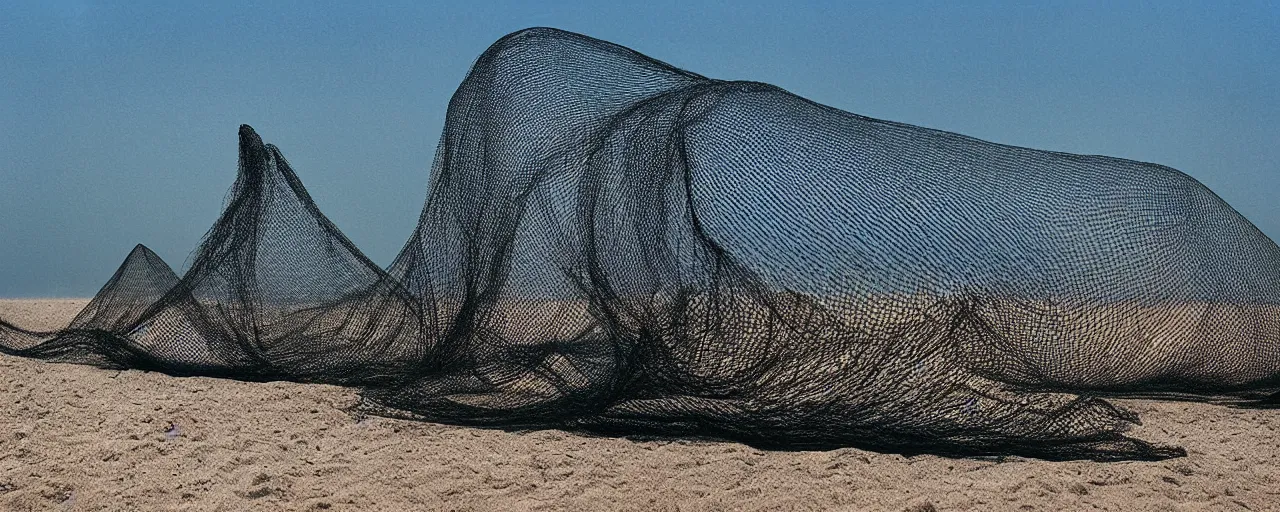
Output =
[{"x1": 0, "y1": 0, "x2": 1280, "y2": 297}]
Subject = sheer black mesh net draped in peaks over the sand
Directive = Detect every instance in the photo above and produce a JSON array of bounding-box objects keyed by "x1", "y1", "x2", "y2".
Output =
[{"x1": 0, "y1": 28, "x2": 1280, "y2": 460}]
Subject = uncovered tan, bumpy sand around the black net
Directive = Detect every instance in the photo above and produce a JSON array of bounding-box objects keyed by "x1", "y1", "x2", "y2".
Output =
[{"x1": 0, "y1": 300, "x2": 1280, "y2": 511}]
